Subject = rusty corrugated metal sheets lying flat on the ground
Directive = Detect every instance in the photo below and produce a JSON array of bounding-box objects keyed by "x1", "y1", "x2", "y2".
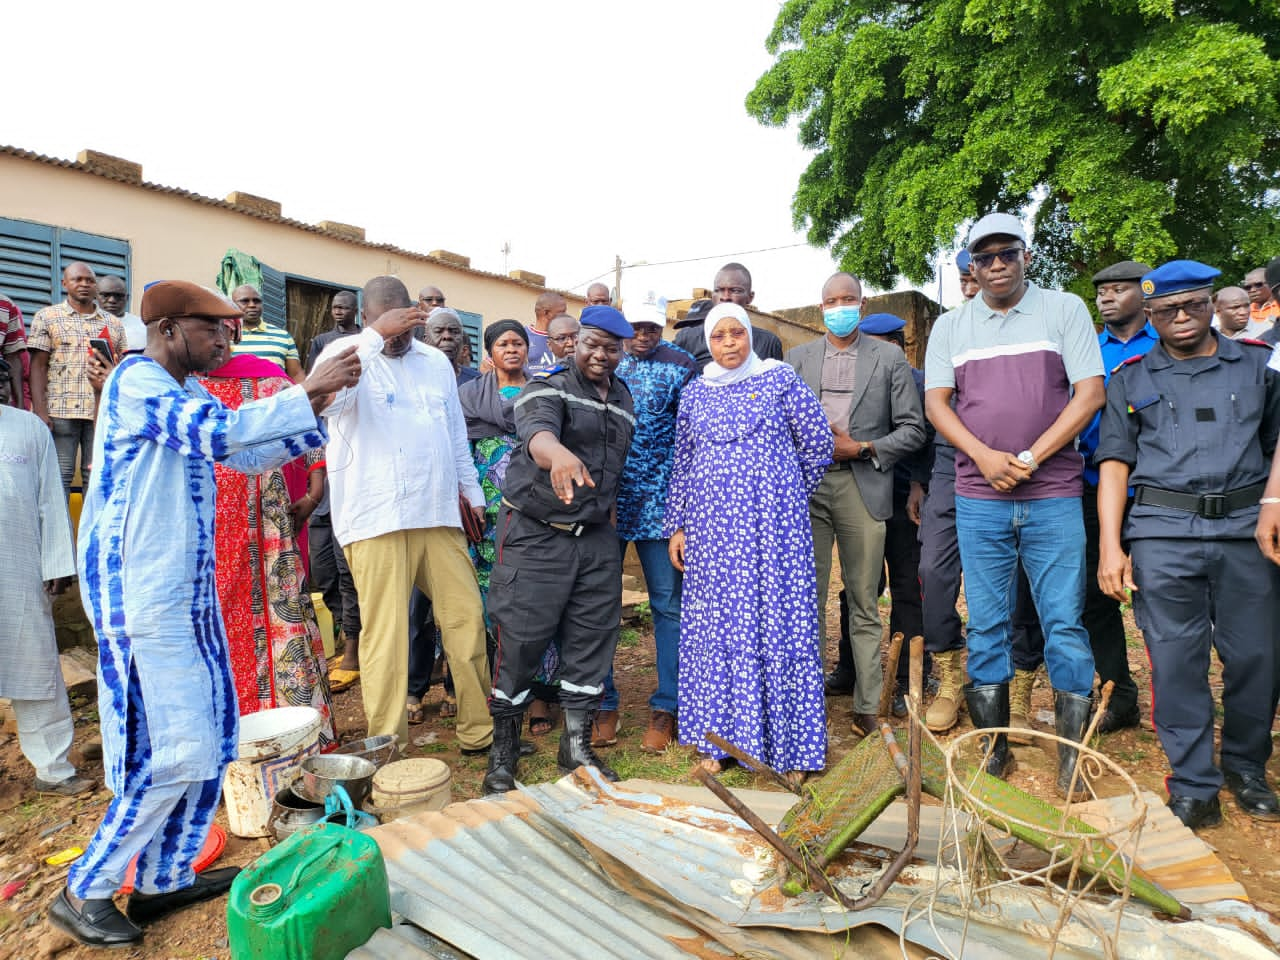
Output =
[{"x1": 372, "y1": 778, "x2": 1272, "y2": 960}]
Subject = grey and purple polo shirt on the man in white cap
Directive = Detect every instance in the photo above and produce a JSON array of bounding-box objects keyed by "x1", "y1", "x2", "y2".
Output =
[{"x1": 924, "y1": 283, "x2": 1103, "y2": 500}]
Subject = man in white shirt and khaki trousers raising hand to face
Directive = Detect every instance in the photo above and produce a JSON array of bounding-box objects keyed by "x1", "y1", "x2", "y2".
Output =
[{"x1": 321, "y1": 276, "x2": 493, "y2": 755}]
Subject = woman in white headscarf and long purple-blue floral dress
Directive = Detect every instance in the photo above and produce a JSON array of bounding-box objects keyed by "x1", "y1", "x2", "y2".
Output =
[{"x1": 663, "y1": 303, "x2": 833, "y2": 781}]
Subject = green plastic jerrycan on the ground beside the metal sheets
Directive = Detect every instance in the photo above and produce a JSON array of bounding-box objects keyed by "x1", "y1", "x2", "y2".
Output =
[{"x1": 227, "y1": 823, "x2": 392, "y2": 960}]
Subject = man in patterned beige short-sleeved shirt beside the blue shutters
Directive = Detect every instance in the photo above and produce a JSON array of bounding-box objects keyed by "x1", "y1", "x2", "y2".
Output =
[{"x1": 27, "y1": 262, "x2": 124, "y2": 495}]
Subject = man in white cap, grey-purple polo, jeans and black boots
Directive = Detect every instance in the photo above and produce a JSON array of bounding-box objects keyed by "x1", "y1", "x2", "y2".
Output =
[{"x1": 925, "y1": 214, "x2": 1105, "y2": 795}]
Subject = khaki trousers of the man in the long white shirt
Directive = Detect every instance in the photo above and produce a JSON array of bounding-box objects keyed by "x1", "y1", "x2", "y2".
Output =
[{"x1": 343, "y1": 526, "x2": 493, "y2": 750}]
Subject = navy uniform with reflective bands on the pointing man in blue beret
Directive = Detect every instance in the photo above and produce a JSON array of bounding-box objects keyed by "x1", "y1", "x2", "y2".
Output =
[{"x1": 489, "y1": 365, "x2": 636, "y2": 717}]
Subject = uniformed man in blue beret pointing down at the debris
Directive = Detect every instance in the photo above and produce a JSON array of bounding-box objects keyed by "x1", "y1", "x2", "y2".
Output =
[{"x1": 484, "y1": 306, "x2": 635, "y2": 794}]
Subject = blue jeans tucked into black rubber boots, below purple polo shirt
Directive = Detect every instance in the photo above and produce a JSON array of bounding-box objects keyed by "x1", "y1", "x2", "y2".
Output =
[{"x1": 956, "y1": 497, "x2": 1093, "y2": 696}]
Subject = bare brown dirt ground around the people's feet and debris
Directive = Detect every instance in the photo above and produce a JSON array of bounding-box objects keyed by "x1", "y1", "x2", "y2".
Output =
[{"x1": 0, "y1": 593, "x2": 1280, "y2": 960}]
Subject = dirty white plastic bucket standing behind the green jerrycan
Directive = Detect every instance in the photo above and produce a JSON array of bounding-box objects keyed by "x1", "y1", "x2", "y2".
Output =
[{"x1": 223, "y1": 707, "x2": 324, "y2": 837}]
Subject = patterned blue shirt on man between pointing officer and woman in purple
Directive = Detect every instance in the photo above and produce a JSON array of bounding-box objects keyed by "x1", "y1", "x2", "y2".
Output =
[{"x1": 617, "y1": 340, "x2": 699, "y2": 540}]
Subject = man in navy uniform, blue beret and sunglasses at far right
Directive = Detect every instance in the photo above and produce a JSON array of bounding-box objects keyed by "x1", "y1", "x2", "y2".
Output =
[{"x1": 1093, "y1": 260, "x2": 1280, "y2": 829}]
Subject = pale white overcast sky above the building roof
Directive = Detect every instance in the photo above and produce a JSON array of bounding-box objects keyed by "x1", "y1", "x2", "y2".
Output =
[{"x1": 0, "y1": 0, "x2": 957, "y2": 308}]
